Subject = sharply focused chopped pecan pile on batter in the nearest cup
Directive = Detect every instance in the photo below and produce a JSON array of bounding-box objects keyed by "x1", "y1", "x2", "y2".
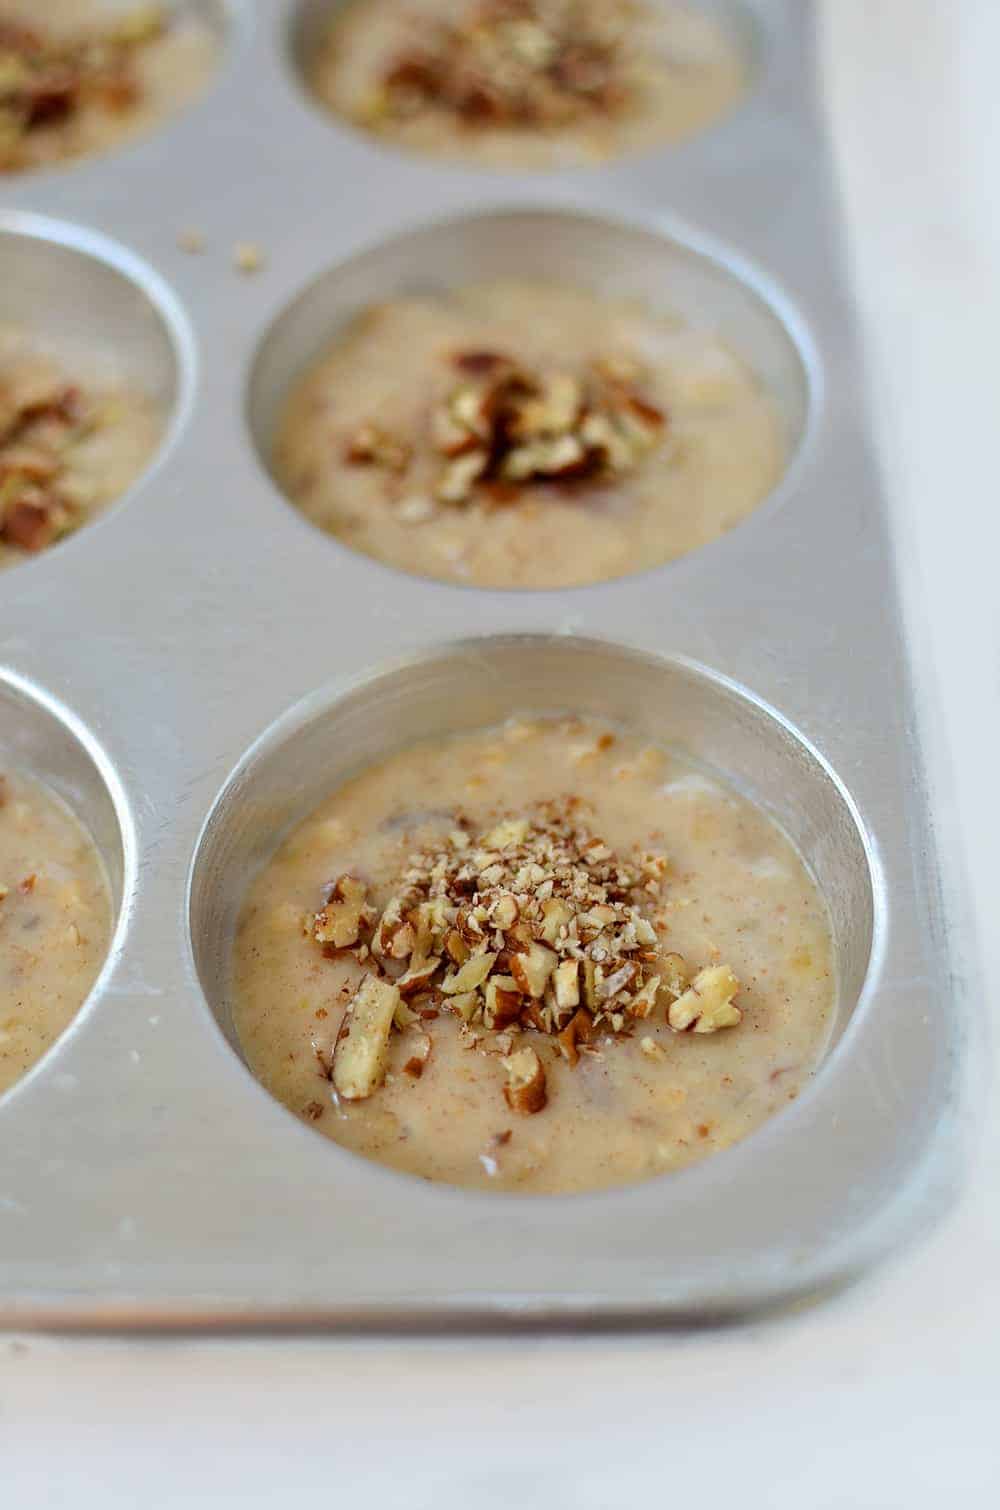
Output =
[{"x1": 305, "y1": 802, "x2": 742, "y2": 1110}]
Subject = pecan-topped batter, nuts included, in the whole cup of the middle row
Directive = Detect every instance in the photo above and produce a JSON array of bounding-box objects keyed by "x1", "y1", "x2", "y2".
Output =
[{"x1": 273, "y1": 281, "x2": 787, "y2": 587}]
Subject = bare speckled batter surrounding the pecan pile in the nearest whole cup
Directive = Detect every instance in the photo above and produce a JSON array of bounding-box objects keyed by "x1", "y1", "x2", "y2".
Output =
[{"x1": 233, "y1": 719, "x2": 835, "y2": 1191}]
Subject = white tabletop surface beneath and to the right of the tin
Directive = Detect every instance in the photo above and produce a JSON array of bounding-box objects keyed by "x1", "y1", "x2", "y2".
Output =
[{"x1": 0, "y1": 0, "x2": 1000, "y2": 1510}]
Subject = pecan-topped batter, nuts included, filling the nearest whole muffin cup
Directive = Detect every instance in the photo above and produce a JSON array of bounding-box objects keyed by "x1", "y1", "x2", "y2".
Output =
[{"x1": 234, "y1": 719, "x2": 834, "y2": 1191}]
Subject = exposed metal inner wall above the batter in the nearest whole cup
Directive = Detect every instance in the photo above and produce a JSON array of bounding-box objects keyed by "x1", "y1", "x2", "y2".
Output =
[{"x1": 189, "y1": 636, "x2": 876, "y2": 1081}]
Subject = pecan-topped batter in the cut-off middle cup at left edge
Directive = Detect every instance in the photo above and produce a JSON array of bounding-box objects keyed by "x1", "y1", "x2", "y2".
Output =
[{"x1": 0, "y1": 326, "x2": 163, "y2": 568}]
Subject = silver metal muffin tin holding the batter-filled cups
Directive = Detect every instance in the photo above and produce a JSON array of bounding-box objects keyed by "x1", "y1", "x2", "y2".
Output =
[{"x1": 0, "y1": 0, "x2": 964, "y2": 1326}]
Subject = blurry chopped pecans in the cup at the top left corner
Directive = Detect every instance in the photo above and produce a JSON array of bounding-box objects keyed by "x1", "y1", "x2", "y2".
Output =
[{"x1": 0, "y1": 5, "x2": 169, "y2": 172}]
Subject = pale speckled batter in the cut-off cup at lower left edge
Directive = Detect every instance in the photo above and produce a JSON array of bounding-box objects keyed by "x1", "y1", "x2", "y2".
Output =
[{"x1": 0, "y1": 763, "x2": 112, "y2": 1093}]
